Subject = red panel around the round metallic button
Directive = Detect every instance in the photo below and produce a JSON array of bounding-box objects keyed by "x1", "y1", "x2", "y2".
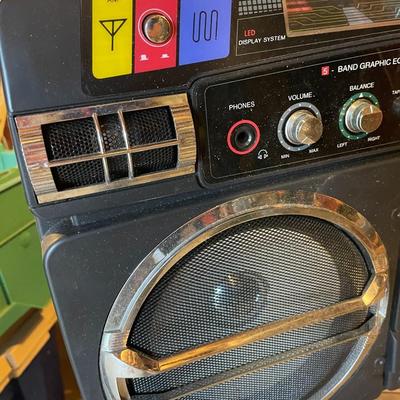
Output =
[{"x1": 135, "y1": 0, "x2": 178, "y2": 73}]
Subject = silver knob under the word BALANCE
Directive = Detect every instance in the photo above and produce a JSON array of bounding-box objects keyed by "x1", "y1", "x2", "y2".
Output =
[{"x1": 345, "y1": 99, "x2": 383, "y2": 133}]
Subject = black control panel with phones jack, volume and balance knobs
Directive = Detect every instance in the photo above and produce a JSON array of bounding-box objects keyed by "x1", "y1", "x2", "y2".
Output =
[{"x1": 201, "y1": 50, "x2": 400, "y2": 183}]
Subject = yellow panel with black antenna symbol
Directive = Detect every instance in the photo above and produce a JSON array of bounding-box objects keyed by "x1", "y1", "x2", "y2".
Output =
[{"x1": 92, "y1": 0, "x2": 133, "y2": 79}]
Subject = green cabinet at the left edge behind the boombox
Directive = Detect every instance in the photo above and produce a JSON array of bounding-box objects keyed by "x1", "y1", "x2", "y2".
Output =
[{"x1": 0, "y1": 169, "x2": 50, "y2": 336}]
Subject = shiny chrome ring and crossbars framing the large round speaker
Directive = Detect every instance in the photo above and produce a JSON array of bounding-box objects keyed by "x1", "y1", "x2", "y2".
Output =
[{"x1": 100, "y1": 191, "x2": 388, "y2": 400}]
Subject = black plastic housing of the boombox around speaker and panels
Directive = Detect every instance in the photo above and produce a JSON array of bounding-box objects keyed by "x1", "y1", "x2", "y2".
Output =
[{"x1": 0, "y1": 0, "x2": 400, "y2": 400}]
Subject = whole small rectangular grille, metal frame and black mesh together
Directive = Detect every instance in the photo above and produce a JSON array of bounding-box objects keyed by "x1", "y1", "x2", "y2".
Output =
[{"x1": 16, "y1": 95, "x2": 196, "y2": 203}]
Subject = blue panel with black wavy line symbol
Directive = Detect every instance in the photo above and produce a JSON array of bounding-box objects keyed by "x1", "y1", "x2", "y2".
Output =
[{"x1": 179, "y1": 0, "x2": 232, "y2": 65}]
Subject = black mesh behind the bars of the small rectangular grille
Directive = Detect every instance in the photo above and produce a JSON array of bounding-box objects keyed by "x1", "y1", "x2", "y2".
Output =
[{"x1": 42, "y1": 107, "x2": 178, "y2": 191}]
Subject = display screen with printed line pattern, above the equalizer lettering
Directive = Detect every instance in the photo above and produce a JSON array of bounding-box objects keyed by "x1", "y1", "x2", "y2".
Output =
[{"x1": 283, "y1": 0, "x2": 400, "y2": 36}]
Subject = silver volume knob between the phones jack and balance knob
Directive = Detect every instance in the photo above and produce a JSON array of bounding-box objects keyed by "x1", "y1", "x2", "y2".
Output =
[{"x1": 285, "y1": 110, "x2": 324, "y2": 146}]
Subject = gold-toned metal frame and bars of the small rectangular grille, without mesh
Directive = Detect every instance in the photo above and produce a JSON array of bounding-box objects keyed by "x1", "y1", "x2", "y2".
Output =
[{"x1": 15, "y1": 94, "x2": 196, "y2": 203}]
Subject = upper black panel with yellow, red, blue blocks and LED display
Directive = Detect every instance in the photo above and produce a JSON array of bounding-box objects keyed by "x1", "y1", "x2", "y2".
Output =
[{"x1": 81, "y1": 0, "x2": 400, "y2": 96}]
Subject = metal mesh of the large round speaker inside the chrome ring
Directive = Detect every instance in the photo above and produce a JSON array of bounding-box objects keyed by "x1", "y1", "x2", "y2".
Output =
[{"x1": 128, "y1": 216, "x2": 370, "y2": 400}]
